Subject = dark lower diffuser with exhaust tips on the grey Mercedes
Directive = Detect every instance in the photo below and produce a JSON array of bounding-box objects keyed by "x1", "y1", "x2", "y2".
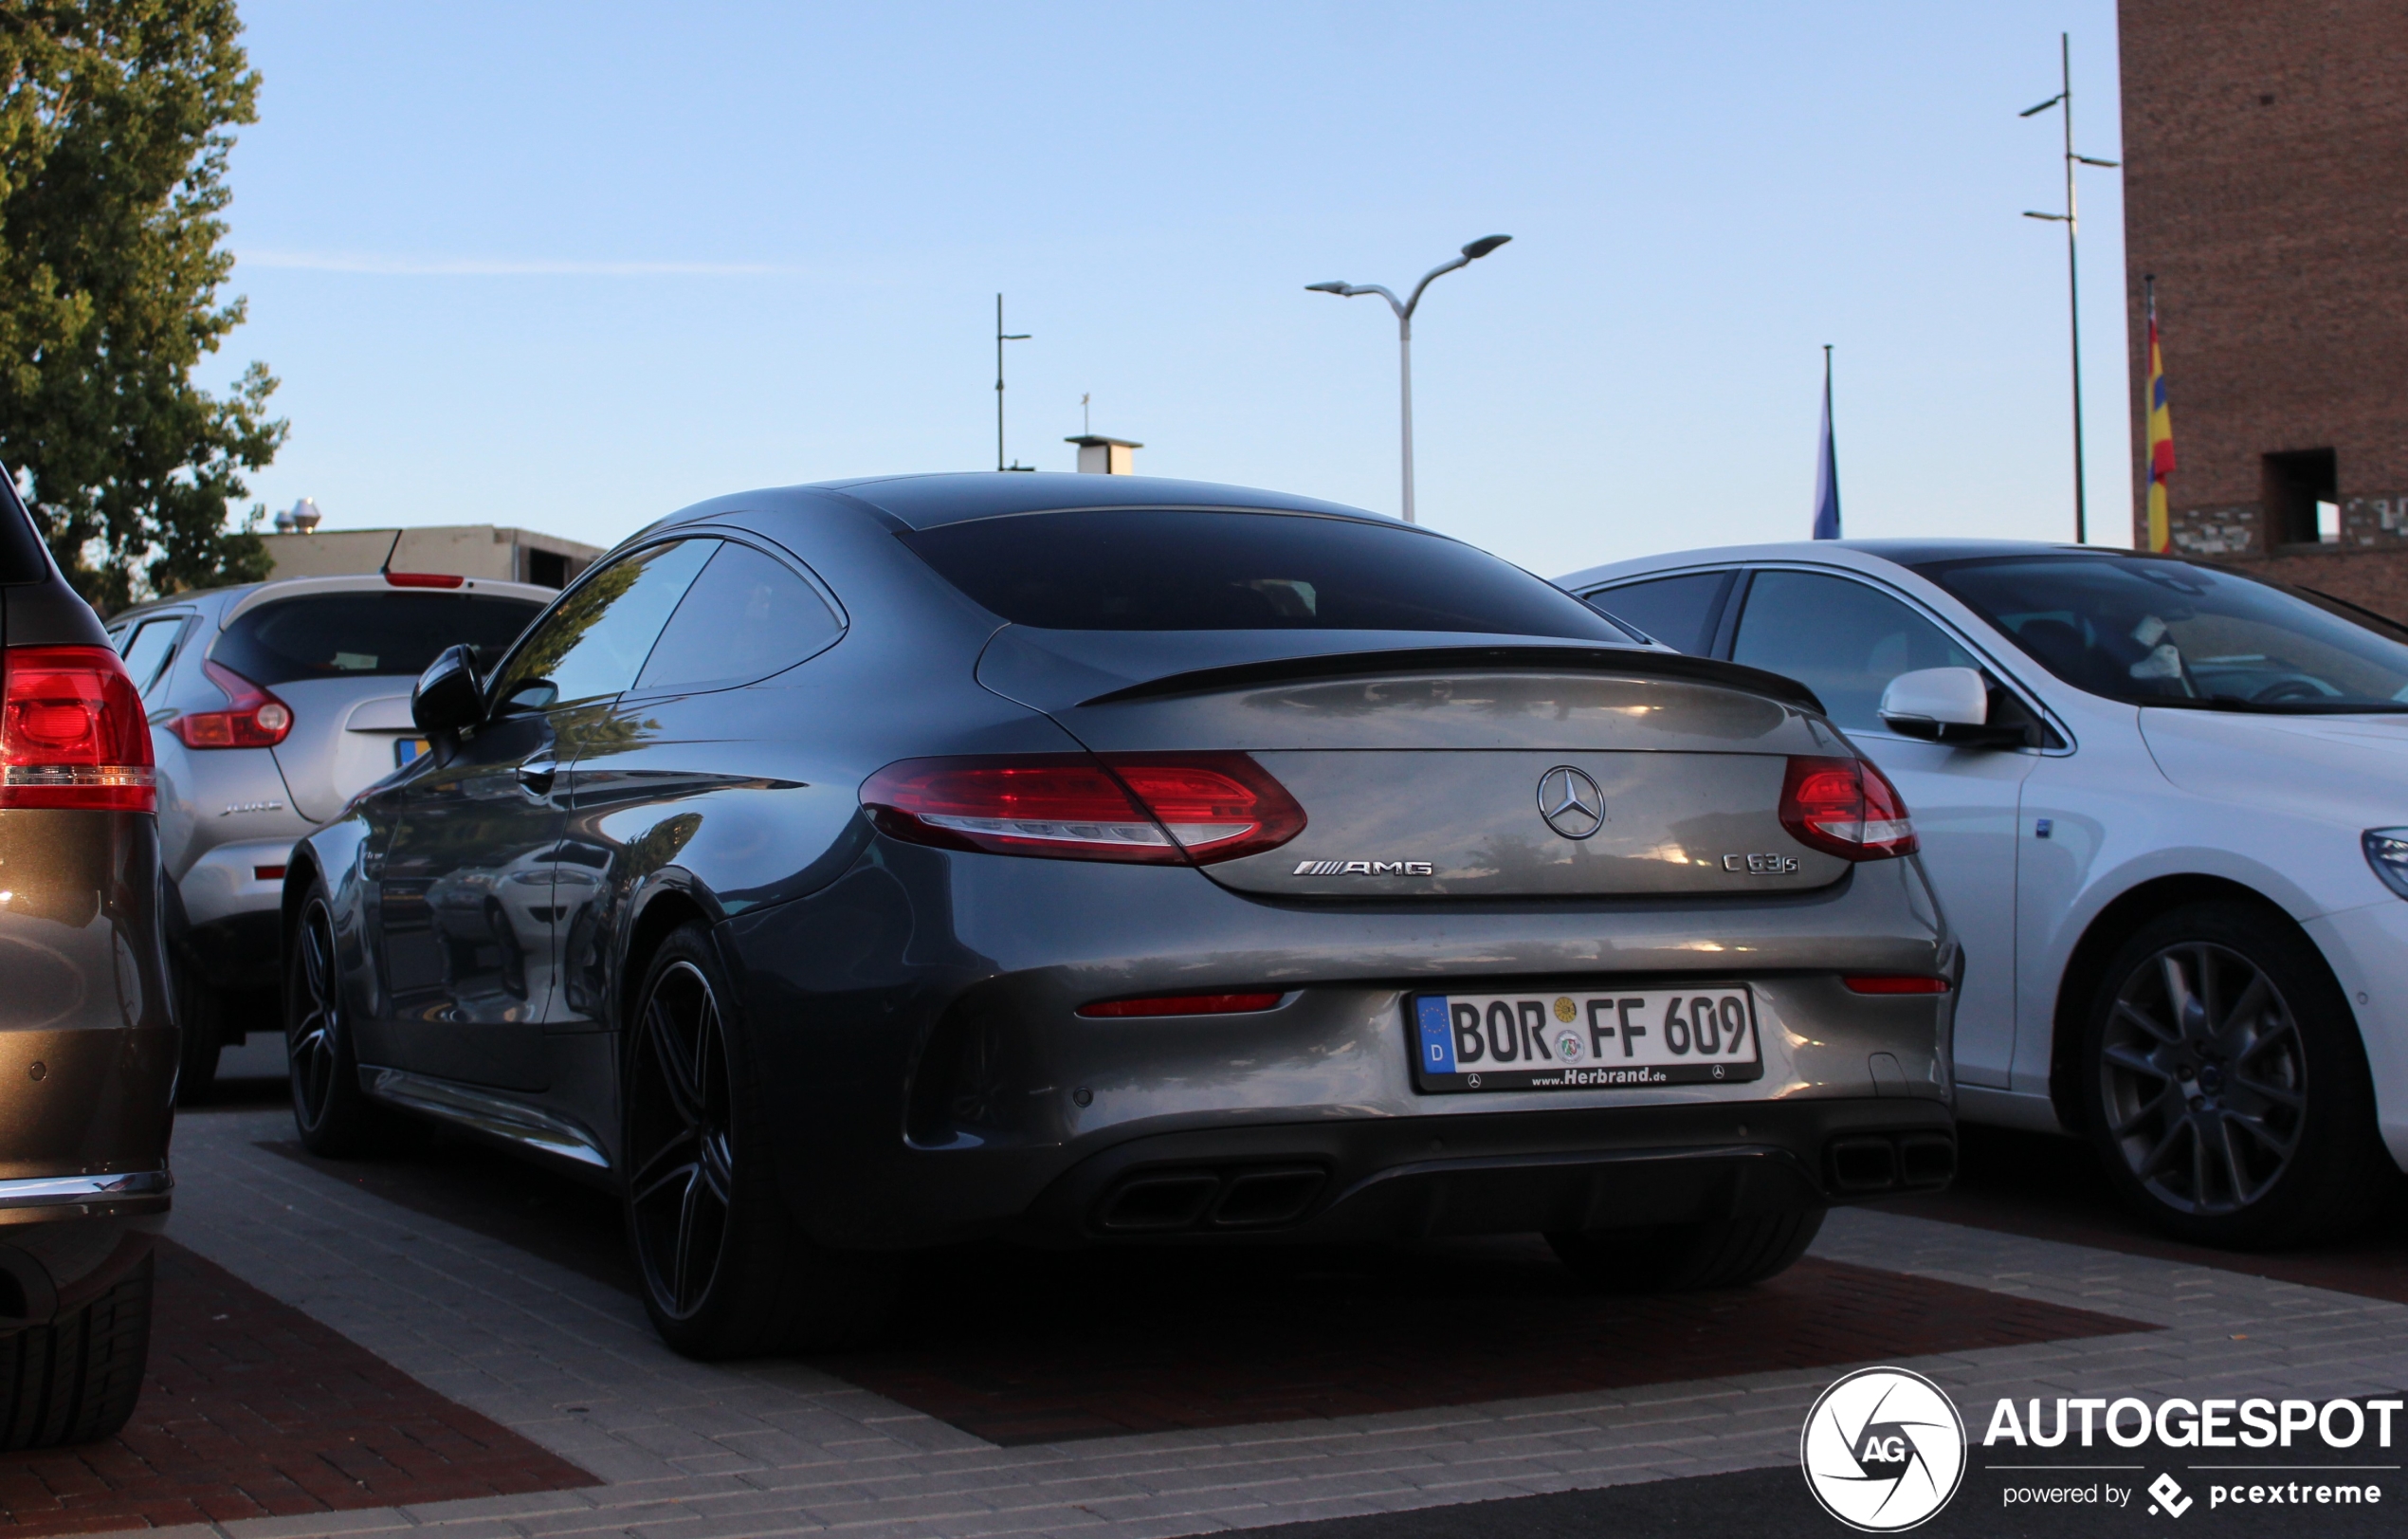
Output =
[{"x1": 1013, "y1": 1101, "x2": 1955, "y2": 1245}]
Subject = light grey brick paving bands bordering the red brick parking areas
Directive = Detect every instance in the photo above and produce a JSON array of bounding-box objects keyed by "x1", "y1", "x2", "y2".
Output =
[{"x1": 75, "y1": 1112, "x2": 2408, "y2": 1539}]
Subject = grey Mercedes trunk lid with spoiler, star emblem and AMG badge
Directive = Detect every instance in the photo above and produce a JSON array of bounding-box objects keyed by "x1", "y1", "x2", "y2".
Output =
[{"x1": 977, "y1": 626, "x2": 1852, "y2": 898}]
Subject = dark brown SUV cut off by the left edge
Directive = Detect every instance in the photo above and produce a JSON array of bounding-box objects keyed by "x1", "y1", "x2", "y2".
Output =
[{"x1": 0, "y1": 469, "x2": 175, "y2": 1450}]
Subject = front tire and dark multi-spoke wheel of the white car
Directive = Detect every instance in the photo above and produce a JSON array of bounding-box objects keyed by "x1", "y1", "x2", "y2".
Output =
[{"x1": 2081, "y1": 901, "x2": 2394, "y2": 1250}]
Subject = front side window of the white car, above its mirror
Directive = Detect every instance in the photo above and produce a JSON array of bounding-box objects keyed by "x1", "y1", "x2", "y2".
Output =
[{"x1": 1731, "y1": 571, "x2": 1981, "y2": 732}]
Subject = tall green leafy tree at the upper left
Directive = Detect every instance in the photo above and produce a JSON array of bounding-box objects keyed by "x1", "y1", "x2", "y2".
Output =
[{"x1": 0, "y1": 0, "x2": 284, "y2": 612}]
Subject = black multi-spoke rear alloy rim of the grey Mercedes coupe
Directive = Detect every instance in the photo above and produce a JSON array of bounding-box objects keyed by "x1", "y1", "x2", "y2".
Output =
[{"x1": 626, "y1": 959, "x2": 735, "y2": 1322}]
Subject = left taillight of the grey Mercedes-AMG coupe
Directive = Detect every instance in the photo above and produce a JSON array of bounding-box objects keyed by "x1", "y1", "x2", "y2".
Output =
[{"x1": 862, "y1": 754, "x2": 1305, "y2": 865}]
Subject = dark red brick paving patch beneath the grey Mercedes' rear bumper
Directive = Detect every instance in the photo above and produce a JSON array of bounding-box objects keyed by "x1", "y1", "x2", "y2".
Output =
[{"x1": 821, "y1": 1257, "x2": 2155, "y2": 1447}]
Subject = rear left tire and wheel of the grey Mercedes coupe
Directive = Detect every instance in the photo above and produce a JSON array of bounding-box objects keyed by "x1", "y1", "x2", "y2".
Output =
[{"x1": 621, "y1": 923, "x2": 891, "y2": 1361}]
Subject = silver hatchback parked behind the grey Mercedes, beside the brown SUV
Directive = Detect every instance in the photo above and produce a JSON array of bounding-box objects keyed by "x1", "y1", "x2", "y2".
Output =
[{"x1": 108, "y1": 573, "x2": 552, "y2": 1098}]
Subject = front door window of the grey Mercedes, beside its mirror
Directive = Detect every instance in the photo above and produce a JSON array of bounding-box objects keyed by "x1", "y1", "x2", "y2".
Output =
[{"x1": 494, "y1": 540, "x2": 720, "y2": 713}]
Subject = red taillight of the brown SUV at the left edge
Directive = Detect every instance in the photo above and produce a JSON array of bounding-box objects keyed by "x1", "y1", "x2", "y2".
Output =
[{"x1": 0, "y1": 646, "x2": 159, "y2": 812}]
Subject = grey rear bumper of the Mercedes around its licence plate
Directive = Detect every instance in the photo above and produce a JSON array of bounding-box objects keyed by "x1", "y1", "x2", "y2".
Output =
[{"x1": 718, "y1": 838, "x2": 1961, "y2": 1250}]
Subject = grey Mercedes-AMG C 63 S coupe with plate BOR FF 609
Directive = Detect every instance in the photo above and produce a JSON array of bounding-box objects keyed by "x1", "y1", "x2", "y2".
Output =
[{"x1": 284, "y1": 474, "x2": 1961, "y2": 1356}]
